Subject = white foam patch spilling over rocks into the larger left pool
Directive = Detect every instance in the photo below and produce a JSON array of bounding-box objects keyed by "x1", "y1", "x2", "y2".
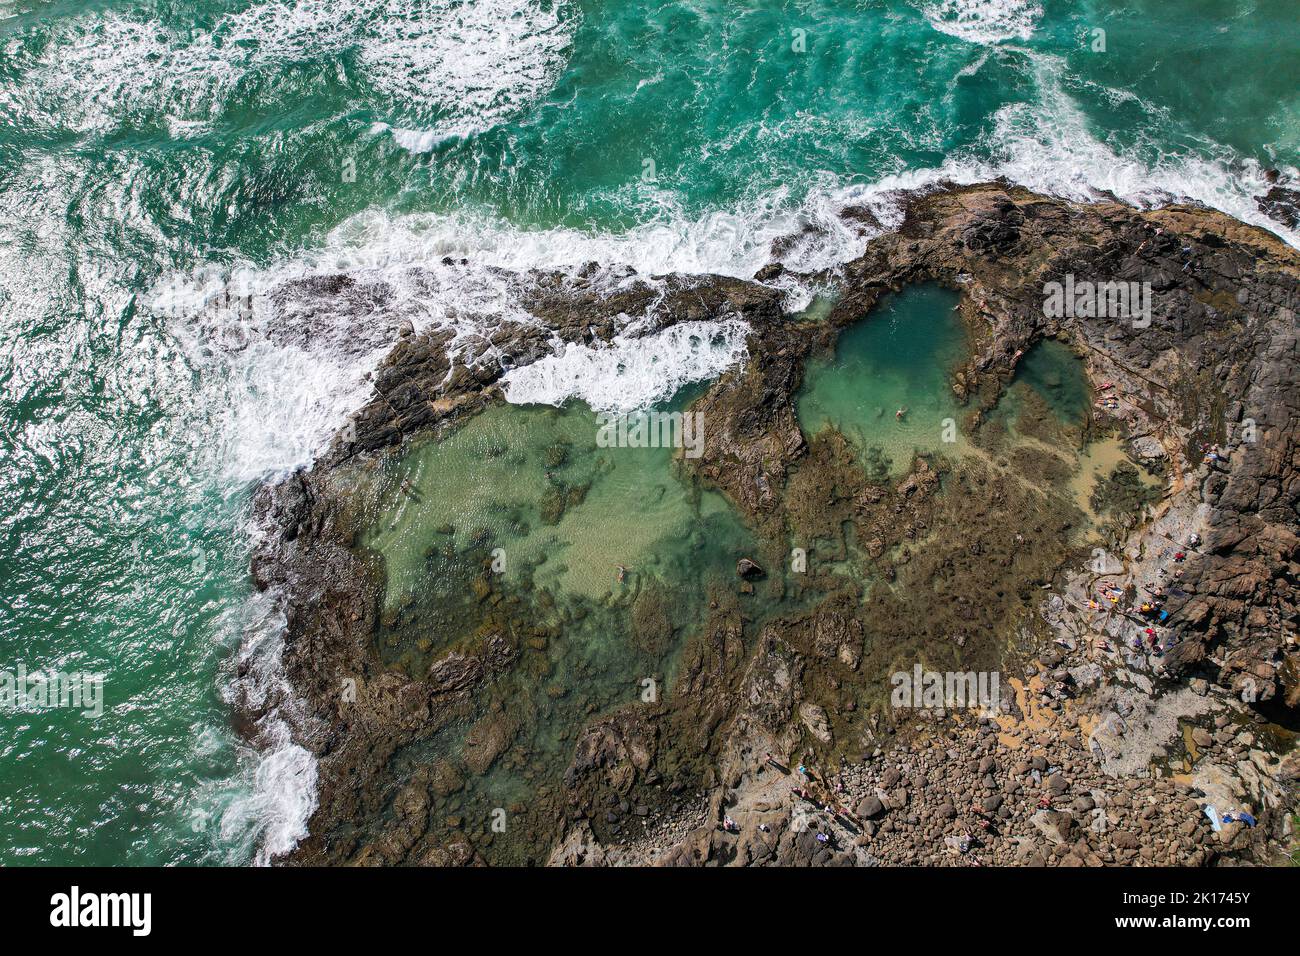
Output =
[{"x1": 503, "y1": 319, "x2": 749, "y2": 412}]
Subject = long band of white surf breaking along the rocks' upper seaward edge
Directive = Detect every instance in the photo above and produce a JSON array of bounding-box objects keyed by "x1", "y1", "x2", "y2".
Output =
[{"x1": 165, "y1": 72, "x2": 1300, "y2": 476}]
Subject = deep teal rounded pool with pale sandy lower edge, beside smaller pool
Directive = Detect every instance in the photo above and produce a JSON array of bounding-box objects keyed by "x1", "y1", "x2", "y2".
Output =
[{"x1": 797, "y1": 285, "x2": 967, "y2": 475}]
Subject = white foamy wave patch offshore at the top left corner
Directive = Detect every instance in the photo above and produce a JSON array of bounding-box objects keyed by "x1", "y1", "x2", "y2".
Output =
[{"x1": 13, "y1": 0, "x2": 575, "y2": 136}]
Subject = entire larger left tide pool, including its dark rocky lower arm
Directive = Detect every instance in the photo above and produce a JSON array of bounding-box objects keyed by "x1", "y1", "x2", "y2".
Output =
[{"x1": 340, "y1": 390, "x2": 783, "y2": 862}]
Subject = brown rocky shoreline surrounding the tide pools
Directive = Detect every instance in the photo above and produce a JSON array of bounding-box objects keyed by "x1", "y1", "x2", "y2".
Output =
[{"x1": 239, "y1": 183, "x2": 1300, "y2": 865}]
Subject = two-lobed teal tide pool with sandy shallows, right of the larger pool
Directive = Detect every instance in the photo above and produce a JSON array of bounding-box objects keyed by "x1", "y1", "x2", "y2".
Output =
[{"x1": 797, "y1": 284, "x2": 1162, "y2": 546}]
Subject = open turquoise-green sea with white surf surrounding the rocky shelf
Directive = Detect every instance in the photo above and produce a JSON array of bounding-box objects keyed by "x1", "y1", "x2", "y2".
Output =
[{"x1": 0, "y1": 0, "x2": 1300, "y2": 864}]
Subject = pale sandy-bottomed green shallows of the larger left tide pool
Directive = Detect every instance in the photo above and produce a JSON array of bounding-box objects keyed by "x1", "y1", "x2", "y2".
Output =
[{"x1": 363, "y1": 405, "x2": 751, "y2": 606}]
